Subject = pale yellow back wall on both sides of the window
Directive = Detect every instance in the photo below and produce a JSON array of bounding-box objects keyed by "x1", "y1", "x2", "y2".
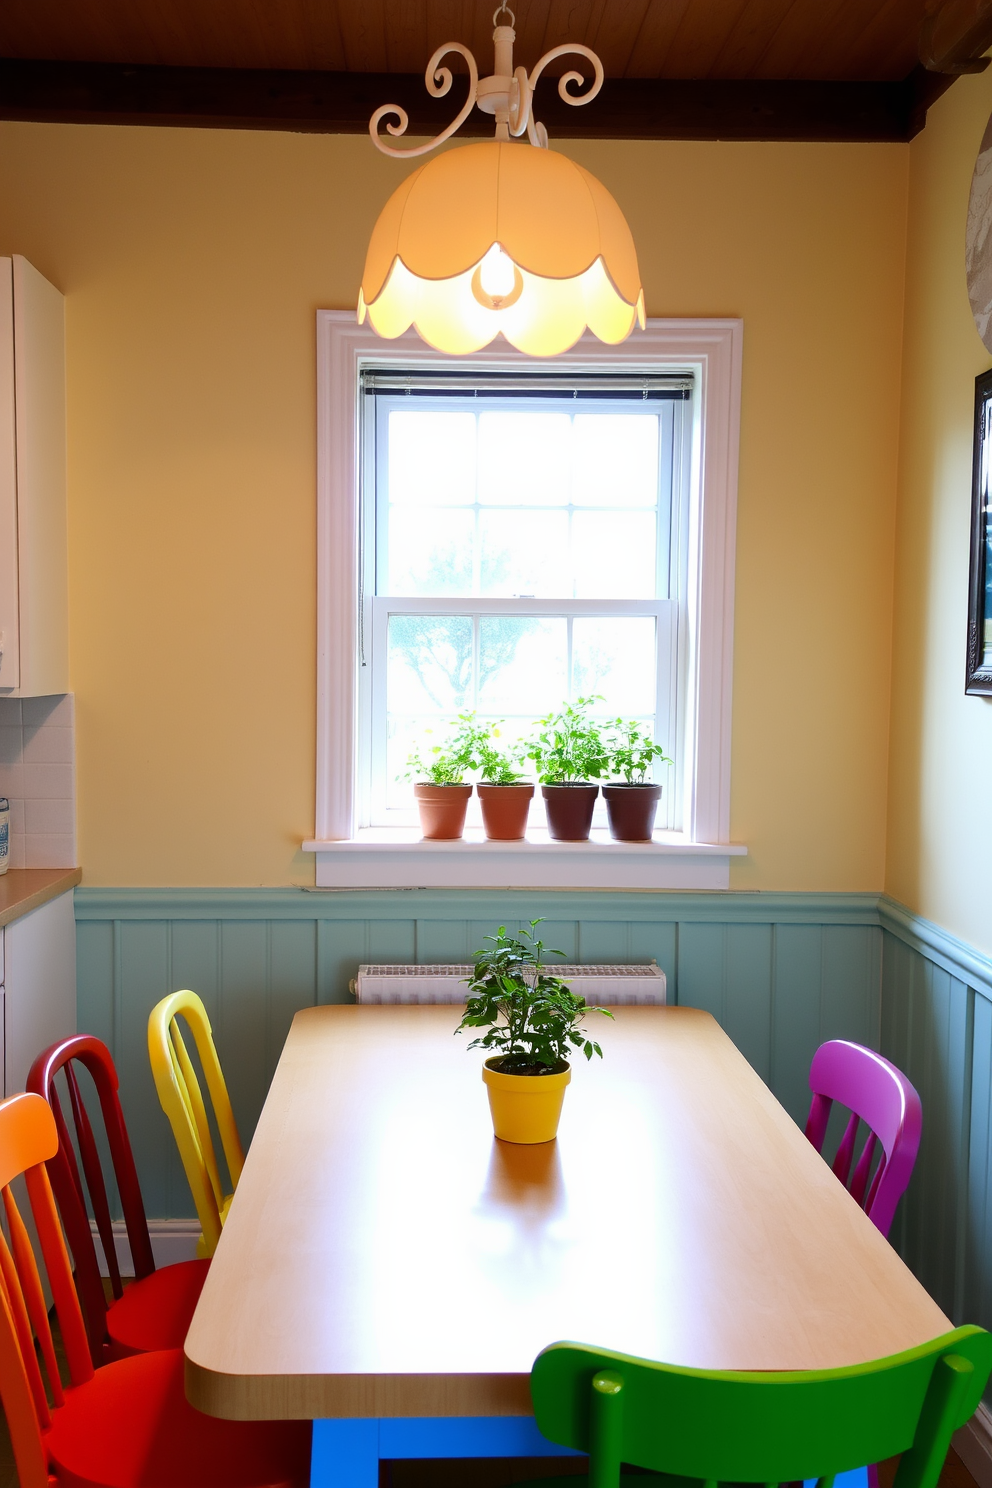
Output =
[{"x1": 0, "y1": 124, "x2": 909, "y2": 890}]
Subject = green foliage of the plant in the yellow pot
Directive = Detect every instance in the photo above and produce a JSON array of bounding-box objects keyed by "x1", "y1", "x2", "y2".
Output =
[{"x1": 457, "y1": 920, "x2": 613, "y2": 1076}]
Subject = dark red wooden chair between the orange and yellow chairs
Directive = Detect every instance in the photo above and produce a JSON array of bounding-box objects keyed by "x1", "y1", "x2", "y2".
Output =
[{"x1": 27, "y1": 1034, "x2": 210, "y2": 1364}]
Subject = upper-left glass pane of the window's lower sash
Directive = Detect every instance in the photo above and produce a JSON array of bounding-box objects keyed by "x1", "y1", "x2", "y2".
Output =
[{"x1": 387, "y1": 615, "x2": 473, "y2": 717}]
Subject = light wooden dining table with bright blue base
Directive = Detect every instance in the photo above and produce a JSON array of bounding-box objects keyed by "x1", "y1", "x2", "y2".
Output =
[{"x1": 186, "y1": 1006, "x2": 952, "y2": 1488}]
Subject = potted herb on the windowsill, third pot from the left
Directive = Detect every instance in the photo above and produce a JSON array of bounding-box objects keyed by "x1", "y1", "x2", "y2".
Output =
[{"x1": 528, "y1": 698, "x2": 610, "y2": 842}]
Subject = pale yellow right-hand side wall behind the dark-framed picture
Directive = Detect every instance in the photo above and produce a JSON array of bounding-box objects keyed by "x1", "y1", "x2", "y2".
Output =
[{"x1": 886, "y1": 73, "x2": 992, "y2": 952}]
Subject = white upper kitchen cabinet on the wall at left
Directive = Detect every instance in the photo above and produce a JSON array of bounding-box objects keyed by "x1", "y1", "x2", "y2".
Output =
[{"x1": 0, "y1": 254, "x2": 68, "y2": 698}]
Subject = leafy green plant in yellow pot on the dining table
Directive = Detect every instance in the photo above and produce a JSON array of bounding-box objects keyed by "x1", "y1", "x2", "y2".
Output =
[{"x1": 457, "y1": 920, "x2": 613, "y2": 1144}]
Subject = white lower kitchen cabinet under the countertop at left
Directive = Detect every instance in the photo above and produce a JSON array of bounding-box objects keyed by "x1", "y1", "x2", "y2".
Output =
[{"x1": 0, "y1": 893, "x2": 76, "y2": 1095}]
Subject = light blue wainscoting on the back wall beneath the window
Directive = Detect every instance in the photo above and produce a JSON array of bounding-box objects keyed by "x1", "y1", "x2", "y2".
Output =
[{"x1": 76, "y1": 888, "x2": 882, "y2": 1219}]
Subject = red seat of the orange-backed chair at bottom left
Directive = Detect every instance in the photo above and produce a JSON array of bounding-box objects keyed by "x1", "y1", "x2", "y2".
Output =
[{"x1": 45, "y1": 1348, "x2": 311, "y2": 1488}]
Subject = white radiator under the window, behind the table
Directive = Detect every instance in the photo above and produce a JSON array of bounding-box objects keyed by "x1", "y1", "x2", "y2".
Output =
[{"x1": 351, "y1": 961, "x2": 665, "y2": 1007}]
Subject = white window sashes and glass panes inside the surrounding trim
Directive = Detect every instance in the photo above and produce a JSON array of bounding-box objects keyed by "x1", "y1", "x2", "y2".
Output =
[{"x1": 358, "y1": 371, "x2": 692, "y2": 829}]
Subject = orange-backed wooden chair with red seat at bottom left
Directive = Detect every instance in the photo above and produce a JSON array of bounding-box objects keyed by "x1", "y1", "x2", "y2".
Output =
[{"x1": 0, "y1": 1094, "x2": 311, "y2": 1488}]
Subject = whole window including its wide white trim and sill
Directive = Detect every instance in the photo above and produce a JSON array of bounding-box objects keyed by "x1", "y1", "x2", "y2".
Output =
[{"x1": 310, "y1": 311, "x2": 745, "y2": 888}]
